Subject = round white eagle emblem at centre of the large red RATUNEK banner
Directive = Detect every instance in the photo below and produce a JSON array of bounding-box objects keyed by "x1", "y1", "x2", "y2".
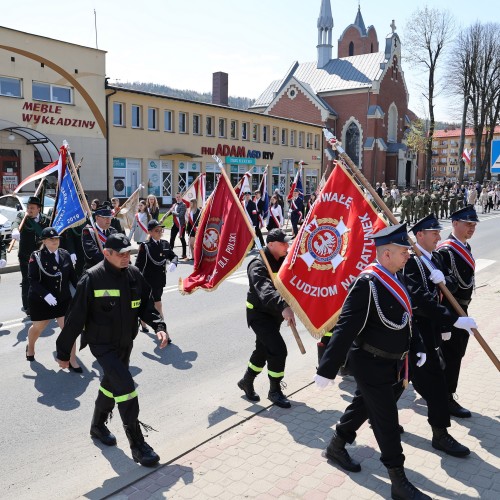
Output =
[{"x1": 299, "y1": 217, "x2": 349, "y2": 272}]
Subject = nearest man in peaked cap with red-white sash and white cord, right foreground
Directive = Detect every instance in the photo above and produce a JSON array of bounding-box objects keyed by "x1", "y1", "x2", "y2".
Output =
[{"x1": 314, "y1": 224, "x2": 430, "y2": 499}]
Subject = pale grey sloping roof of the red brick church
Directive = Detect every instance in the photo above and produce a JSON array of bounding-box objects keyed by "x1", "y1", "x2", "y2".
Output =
[{"x1": 252, "y1": 52, "x2": 386, "y2": 108}]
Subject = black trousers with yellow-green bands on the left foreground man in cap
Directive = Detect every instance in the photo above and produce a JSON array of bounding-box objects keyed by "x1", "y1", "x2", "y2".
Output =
[{"x1": 90, "y1": 344, "x2": 139, "y2": 425}]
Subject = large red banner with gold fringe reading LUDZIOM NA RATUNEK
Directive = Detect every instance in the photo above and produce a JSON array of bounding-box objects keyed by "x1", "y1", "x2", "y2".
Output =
[{"x1": 275, "y1": 162, "x2": 387, "y2": 337}]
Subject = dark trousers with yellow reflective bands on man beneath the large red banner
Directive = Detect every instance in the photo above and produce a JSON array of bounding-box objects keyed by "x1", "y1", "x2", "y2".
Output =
[{"x1": 247, "y1": 310, "x2": 288, "y2": 380}]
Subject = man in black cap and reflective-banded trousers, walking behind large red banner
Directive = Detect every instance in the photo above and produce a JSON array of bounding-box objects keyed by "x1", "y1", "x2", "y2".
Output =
[{"x1": 238, "y1": 229, "x2": 295, "y2": 408}]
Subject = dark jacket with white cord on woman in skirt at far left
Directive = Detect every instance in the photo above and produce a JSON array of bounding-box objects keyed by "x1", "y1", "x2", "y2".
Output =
[{"x1": 28, "y1": 247, "x2": 78, "y2": 302}]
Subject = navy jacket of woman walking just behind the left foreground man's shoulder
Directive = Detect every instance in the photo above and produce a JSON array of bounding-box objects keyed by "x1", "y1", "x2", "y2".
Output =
[{"x1": 135, "y1": 238, "x2": 178, "y2": 289}]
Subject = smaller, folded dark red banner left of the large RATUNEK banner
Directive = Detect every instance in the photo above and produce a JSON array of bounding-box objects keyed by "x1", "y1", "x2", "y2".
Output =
[{"x1": 179, "y1": 175, "x2": 253, "y2": 294}]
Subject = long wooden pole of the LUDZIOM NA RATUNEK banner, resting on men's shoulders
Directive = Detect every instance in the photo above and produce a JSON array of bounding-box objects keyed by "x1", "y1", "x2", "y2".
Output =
[{"x1": 323, "y1": 129, "x2": 500, "y2": 371}]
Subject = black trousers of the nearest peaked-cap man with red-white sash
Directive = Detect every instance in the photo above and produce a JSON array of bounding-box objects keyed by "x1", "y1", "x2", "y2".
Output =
[{"x1": 336, "y1": 348, "x2": 405, "y2": 468}]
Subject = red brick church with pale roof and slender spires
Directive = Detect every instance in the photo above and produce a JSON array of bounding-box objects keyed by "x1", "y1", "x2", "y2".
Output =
[{"x1": 251, "y1": 0, "x2": 420, "y2": 186}]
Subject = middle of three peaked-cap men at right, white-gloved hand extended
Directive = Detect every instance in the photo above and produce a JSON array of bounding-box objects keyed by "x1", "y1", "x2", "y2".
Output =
[{"x1": 404, "y1": 214, "x2": 475, "y2": 457}]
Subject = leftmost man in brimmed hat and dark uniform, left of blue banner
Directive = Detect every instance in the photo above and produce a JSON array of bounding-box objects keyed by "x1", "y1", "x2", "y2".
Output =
[{"x1": 12, "y1": 196, "x2": 50, "y2": 316}]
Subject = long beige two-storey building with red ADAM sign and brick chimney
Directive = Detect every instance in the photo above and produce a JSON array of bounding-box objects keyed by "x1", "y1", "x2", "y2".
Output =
[{"x1": 107, "y1": 84, "x2": 323, "y2": 205}]
